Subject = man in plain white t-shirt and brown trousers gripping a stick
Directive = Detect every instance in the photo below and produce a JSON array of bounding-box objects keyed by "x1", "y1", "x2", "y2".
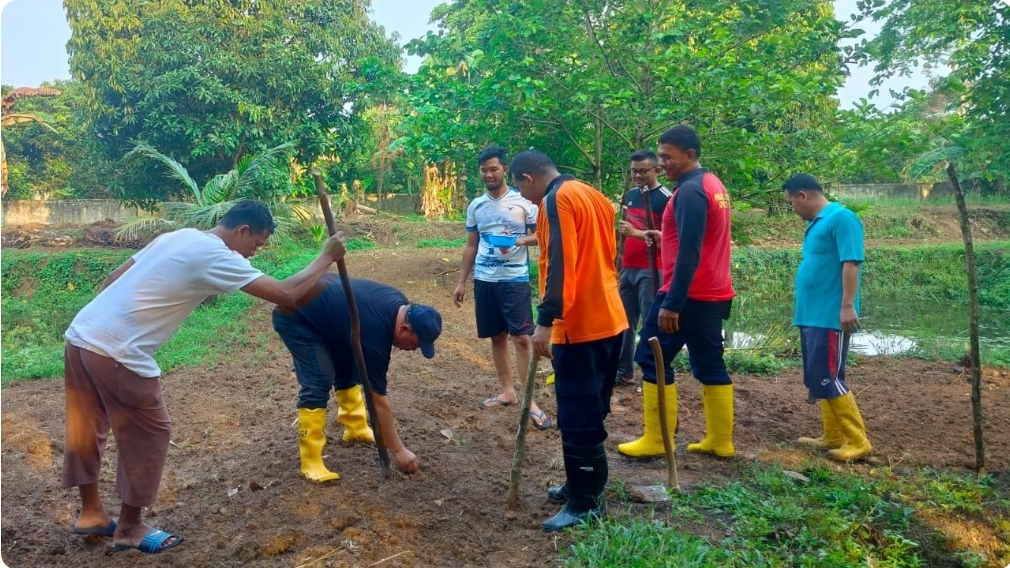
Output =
[{"x1": 63, "y1": 200, "x2": 345, "y2": 554}]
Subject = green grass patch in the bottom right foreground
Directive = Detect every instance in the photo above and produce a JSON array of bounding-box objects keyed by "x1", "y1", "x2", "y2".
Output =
[{"x1": 562, "y1": 460, "x2": 1010, "y2": 568}]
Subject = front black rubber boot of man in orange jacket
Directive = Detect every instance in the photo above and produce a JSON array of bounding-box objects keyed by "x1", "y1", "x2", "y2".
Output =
[{"x1": 541, "y1": 444, "x2": 609, "y2": 533}]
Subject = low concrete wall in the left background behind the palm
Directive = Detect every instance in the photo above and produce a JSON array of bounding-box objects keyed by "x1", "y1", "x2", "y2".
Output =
[{"x1": 0, "y1": 193, "x2": 421, "y2": 226}]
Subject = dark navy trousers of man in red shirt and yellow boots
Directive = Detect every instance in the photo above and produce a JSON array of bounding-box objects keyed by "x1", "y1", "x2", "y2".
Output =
[{"x1": 634, "y1": 293, "x2": 733, "y2": 386}]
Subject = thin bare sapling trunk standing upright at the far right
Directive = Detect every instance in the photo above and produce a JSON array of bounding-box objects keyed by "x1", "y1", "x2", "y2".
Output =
[{"x1": 946, "y1": 162, "x2": 986, "y2": 475}]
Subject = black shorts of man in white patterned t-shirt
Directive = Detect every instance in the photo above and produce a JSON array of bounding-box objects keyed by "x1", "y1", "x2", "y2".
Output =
[{"x1": 474, "y1": 280, "x2": 533, "y2": 339}]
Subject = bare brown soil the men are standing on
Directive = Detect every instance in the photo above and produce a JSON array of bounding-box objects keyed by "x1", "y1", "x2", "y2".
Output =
[{"x1": 0, "y1": 230, "x2": 1010, "y2": 567}]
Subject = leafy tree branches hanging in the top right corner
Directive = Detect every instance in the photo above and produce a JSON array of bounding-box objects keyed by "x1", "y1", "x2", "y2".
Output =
[{"x1": 859, "y1": 0, "x2": 1010, "y2": 192}]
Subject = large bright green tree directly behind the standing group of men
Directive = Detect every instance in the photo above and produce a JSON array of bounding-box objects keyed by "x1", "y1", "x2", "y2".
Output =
[{"x1": 408, "y1": 0, "x2": 850, "y2": 202}]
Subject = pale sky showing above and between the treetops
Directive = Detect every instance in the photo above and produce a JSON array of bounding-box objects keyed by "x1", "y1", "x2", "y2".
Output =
[{"x1": 0, "y1": 0, "x2": 927, "y2": 108}]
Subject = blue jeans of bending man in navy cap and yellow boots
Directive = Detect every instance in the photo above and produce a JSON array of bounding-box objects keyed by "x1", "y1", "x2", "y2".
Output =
[{"x1": 273, "y1": 310, "x2": 357, "y2": 409}]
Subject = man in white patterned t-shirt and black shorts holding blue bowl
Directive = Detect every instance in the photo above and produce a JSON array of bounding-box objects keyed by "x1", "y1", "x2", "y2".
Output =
[{"x1": 452, "y1": 146, "x2": 550, "y2": 430}]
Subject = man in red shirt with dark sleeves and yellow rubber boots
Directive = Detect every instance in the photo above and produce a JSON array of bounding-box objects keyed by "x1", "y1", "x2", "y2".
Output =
[{"x1": 617, "y1": 125, "x2": 736, "y2": 458}]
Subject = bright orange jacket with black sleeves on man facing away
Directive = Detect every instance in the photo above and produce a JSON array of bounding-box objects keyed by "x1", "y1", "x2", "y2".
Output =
[{"x1": 536, "y1": 176, "x2": 628, "y2": 345}]
